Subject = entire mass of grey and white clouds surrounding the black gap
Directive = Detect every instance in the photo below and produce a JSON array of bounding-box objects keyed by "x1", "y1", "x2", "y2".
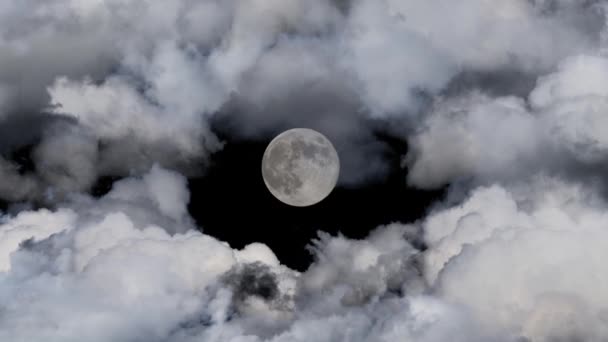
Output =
[{"x1": 0, "y1": 0, "x2": 608, "y2": 342}]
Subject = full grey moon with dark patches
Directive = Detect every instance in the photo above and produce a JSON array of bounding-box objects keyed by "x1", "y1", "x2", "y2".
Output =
[{"x1": 262, "y1": 128, "x2": 340, "y2": 207}]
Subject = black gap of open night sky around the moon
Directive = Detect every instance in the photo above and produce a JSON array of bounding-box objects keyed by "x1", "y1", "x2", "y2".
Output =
[{"x1": 189, "y1": 136, "x2": 443, "y2": 270}]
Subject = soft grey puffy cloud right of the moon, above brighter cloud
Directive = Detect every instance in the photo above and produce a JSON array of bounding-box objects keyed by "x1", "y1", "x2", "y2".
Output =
[{"x1": 405, "y1": 93, "x2": 546, "y2": 188}]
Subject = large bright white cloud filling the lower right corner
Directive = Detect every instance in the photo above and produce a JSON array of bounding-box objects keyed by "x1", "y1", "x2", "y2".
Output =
[{"x1": 424, "y1": 178, "x2": 608, "y2": 341}]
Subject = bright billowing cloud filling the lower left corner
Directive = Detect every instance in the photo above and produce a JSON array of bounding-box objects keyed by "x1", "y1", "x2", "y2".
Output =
[{"x1": 0, "y1": 169, "x2": 277, "y2": 341}]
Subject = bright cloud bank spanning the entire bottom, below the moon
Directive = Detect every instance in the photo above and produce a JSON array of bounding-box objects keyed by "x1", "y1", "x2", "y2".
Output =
[{"x1": 0, "y1": 168, "x2": 608, "y2": 341}]
